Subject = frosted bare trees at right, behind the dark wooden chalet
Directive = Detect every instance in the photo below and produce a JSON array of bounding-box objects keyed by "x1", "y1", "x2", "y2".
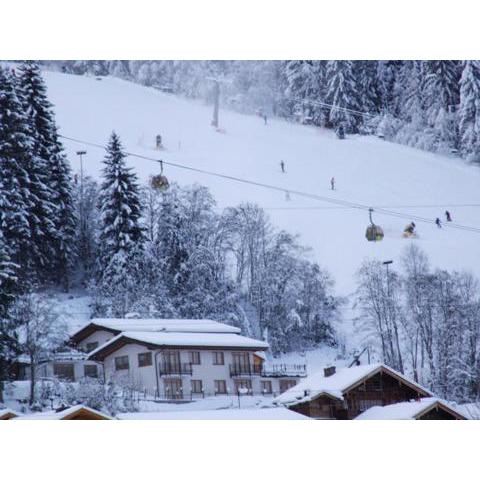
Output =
[{"x1": 357, "y1": 245, "x2": 480, "y2": 402}]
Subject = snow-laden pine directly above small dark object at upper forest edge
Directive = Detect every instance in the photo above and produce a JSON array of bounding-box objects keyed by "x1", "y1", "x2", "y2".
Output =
[{"x1": 326, "y1": 60, "x2": 361, "y2": 133}]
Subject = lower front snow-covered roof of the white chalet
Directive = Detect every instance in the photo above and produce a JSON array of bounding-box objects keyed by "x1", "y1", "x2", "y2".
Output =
[{"x1": 88, "y1": 331, "x2": 268, "y2": 360}]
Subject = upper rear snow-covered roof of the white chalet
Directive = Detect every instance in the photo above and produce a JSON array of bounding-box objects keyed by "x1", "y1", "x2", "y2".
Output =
[{"x1": 71, "y1": 318, "x2": 240, "y2": 343}]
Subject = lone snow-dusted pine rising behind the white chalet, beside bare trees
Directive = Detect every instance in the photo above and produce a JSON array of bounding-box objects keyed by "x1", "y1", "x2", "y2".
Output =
[{"x1": 98, "y1": 132, "x2": 144, "y2": 273}]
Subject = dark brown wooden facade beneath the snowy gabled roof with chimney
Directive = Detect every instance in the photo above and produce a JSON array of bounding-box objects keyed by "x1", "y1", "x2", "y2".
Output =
[{"x1": 288, "y1": 368, "x2": 430, "y2": 420}]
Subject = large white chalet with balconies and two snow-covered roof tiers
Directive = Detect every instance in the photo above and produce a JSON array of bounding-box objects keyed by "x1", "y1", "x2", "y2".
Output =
[{"x1": 62, "y1": 318, "x2": 306, "y2": 400}]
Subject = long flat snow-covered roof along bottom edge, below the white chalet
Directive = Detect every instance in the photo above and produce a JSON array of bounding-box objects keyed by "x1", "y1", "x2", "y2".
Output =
[{"x1": 117, "y1": 407, "x2": 311, "y2": 420}]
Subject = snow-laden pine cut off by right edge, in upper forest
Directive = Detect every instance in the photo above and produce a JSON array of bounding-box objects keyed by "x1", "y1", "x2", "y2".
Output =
[{"x1": 459, "y1": 60, "x2": 480, "y2": 161}]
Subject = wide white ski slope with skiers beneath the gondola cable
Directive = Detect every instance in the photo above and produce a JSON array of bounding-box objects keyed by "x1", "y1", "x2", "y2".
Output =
[{"x1": 44, "y1": 72, "x2": 480, "y2": 295}]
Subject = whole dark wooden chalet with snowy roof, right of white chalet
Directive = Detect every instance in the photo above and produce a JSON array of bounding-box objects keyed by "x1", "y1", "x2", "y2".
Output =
[{"x1": 275, "y1": 363, "x2": 433, "y2": 420}]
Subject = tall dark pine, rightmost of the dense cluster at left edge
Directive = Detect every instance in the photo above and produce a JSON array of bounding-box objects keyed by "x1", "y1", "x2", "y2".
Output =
[{"x1": 18, "y1": 62, "x2": 75, "y2": 289}]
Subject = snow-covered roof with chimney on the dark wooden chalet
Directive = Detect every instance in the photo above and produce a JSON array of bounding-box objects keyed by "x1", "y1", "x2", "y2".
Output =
[{"x1": 275, "y1": 363, "x2": 433, "y2": 405}]
